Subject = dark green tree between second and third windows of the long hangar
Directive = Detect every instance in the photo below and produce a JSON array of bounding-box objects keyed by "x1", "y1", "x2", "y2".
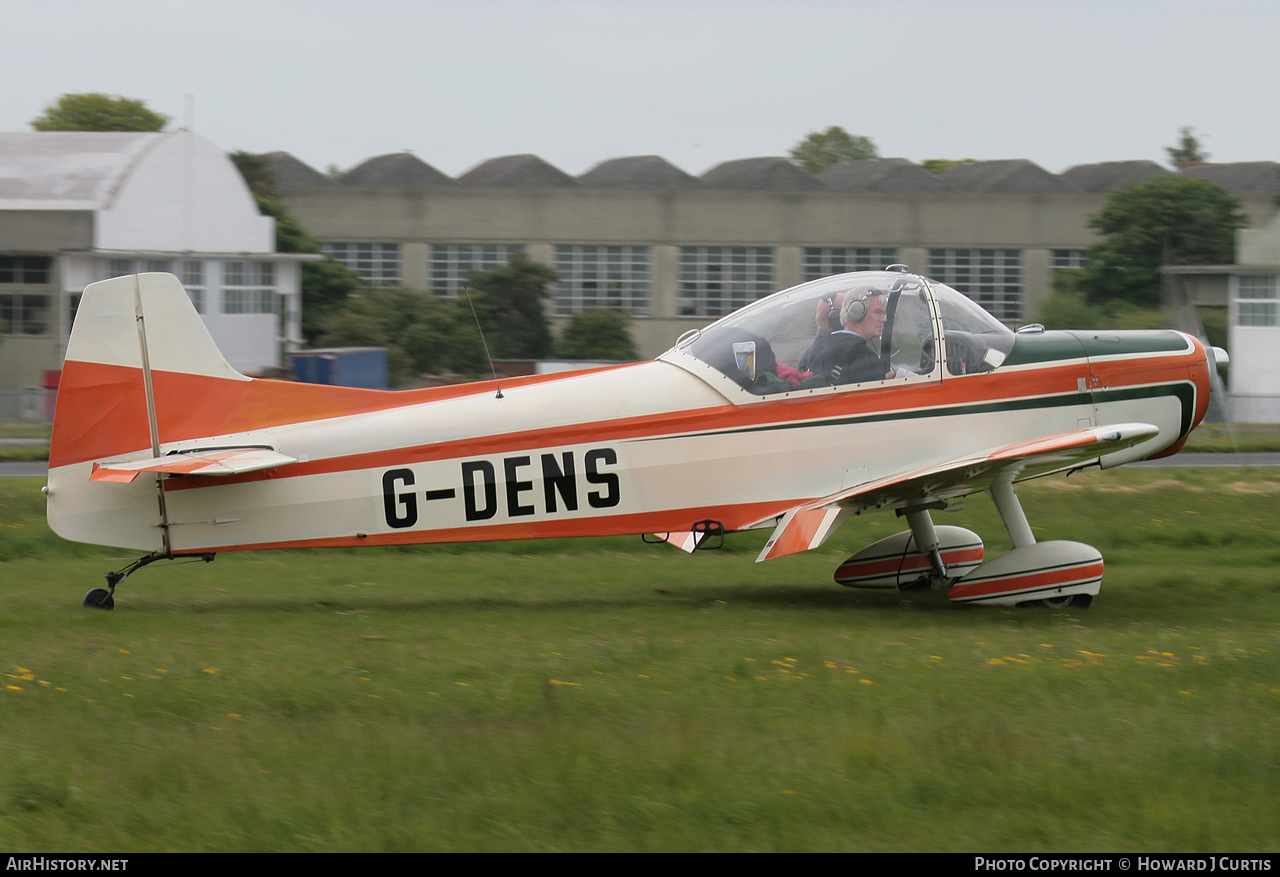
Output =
[{"x1": 468, "y1": 252, "x2": 556, "y2": 360}]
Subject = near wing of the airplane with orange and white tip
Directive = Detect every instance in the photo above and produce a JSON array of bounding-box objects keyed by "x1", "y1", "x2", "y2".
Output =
[{"x1": 755, "y1": 424, "x2": 1160, "y2": 563}]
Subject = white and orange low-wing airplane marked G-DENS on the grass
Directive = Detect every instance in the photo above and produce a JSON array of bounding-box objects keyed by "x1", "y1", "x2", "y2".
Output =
[{"x1": 47, "y1": 266, "x2": 1211, "y2": 608}]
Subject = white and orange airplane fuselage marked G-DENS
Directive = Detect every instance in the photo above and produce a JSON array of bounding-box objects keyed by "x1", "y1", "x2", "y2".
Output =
[{"x1": 50, "y1": 321, "x2": 1207, "y2": 553}]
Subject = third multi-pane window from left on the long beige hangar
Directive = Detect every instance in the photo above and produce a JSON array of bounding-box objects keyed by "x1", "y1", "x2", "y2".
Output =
[{"x1": 554, "y1": 245, "x2": 650, "y2": 316}]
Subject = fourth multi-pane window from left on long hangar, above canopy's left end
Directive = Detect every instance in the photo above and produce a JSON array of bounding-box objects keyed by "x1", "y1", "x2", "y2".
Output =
[{"x1": 680, "y1": 247, "x2": 773, "y2": 316}]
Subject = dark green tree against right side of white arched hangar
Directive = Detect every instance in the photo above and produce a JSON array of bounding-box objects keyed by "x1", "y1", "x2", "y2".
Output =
[{"x1": 228, "y1": 152, "x2": 360, "y2": 347}]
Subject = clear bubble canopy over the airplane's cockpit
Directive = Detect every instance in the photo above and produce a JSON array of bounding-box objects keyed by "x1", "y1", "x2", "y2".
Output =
[{"x1": 662, "y1": 271, "x2": 1015, "y2": 396}]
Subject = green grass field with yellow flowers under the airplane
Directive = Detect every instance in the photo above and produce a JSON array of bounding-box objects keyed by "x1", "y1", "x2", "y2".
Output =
[{"x1": 0, "y1": 470, "x2": 1280, "y2": 853}]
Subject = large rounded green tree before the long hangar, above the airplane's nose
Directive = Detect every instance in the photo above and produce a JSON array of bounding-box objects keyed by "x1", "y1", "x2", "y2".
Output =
[{"x1": 1079, "y1": 174, "x2": 1247, "y2": 307}]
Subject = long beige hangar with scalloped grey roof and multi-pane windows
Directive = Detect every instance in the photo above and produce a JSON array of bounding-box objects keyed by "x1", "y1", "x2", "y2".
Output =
[{"x1": 271, "y1": 152, "x2": 1280, "y2": 356}]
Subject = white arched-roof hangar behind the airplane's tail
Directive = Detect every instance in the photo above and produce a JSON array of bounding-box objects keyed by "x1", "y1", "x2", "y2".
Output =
[{"x1": 0, "y1": 129, "x2": 306, "y2": 389}]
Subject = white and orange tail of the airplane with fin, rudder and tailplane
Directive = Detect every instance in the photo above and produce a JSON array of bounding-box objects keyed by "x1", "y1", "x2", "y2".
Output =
[{"x1": 47, "y1": 274, "x2": 384, "y2": 556}]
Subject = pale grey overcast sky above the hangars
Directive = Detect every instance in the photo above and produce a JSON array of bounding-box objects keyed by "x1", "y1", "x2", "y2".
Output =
[{"x1": 0, "y1": 0, "x2": 1280, "y2": 177}]
